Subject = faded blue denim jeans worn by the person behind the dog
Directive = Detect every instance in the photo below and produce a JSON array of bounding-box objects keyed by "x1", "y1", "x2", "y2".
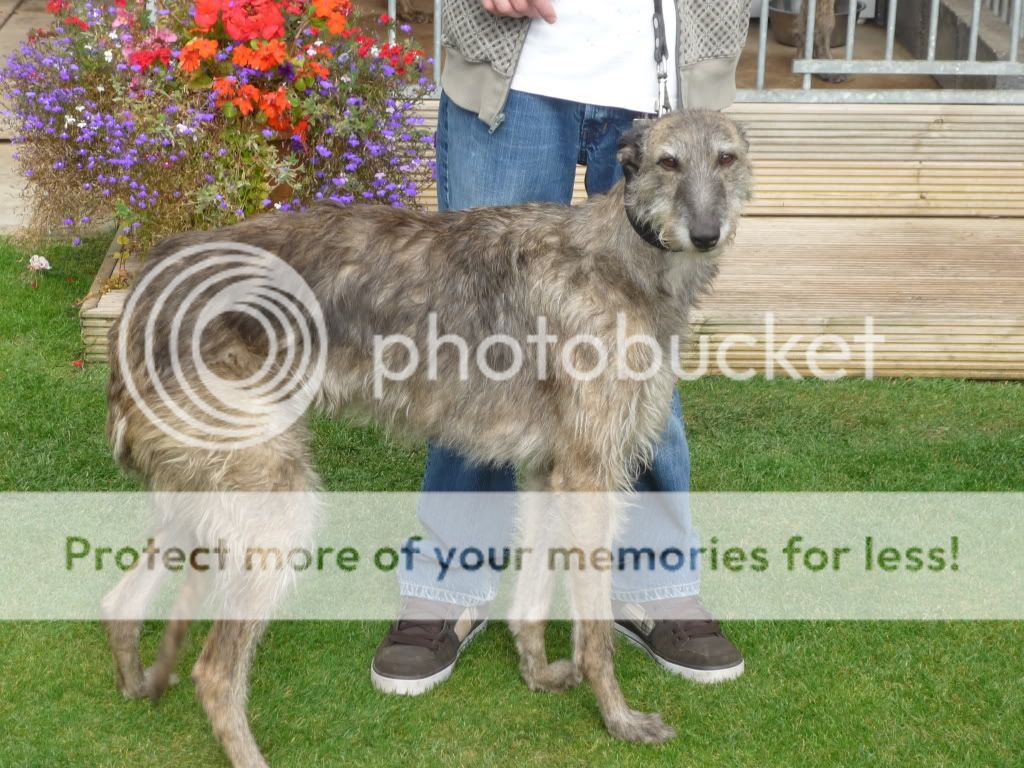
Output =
[{"x1": 399, "y1": 91, "x2": 699, "y2": 605}]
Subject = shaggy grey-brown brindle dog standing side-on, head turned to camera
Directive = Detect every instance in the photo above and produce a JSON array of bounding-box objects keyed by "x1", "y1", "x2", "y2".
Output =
[{"x1": 104, "y1": 112, "x2": 752, "y2": 767}]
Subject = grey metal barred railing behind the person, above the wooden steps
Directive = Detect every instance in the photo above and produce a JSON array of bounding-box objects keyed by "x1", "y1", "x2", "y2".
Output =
[{"x1": 388, "y1": 0, "x2": 1024, "y2": 104}]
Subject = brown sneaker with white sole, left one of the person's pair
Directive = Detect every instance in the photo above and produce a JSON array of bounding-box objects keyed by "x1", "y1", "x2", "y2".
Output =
[{"x1": 370, "y1": 598, "x2": 486, "y2": 696}]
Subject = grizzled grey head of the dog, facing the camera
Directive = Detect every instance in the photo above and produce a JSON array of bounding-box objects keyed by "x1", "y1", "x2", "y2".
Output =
[{"x1": 618, "y1": 111, "x2": 753, "y2": 253}]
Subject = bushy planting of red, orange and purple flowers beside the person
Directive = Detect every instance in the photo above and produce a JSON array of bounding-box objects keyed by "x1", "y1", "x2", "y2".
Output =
[{"x1": 0, "y1": 0, "x2": 433, "y2": 255}]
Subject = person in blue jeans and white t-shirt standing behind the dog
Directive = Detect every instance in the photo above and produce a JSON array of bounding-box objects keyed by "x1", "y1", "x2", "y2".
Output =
[{"x1": 371, "y1": 0, "x2": 750, "y2": 694}]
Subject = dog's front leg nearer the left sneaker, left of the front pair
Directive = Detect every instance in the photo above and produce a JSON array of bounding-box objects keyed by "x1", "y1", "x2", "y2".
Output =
[{"x1": 509, "y1": 477, "x2": 581, "y2": 691}]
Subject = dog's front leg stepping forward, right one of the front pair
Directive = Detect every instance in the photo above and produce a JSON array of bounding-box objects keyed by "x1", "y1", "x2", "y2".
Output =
[{"x1": 567, "y1": 494, "x2": 675, "y2": 743}]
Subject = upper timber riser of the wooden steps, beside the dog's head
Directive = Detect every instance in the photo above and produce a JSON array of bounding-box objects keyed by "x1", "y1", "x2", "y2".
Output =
[{"x1": 411, "y1": 102, "x2": 1024, "y2": 217}]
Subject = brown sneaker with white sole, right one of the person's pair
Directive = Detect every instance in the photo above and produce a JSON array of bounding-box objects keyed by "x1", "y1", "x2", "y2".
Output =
[{"x1": 612, "y1": 597, "x2": 743, "y2": 683}]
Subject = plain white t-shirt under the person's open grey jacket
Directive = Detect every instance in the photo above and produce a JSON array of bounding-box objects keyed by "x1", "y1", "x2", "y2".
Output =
[{"x1": 512, "y1": 0, "x2": 678, "y2": 112}]
